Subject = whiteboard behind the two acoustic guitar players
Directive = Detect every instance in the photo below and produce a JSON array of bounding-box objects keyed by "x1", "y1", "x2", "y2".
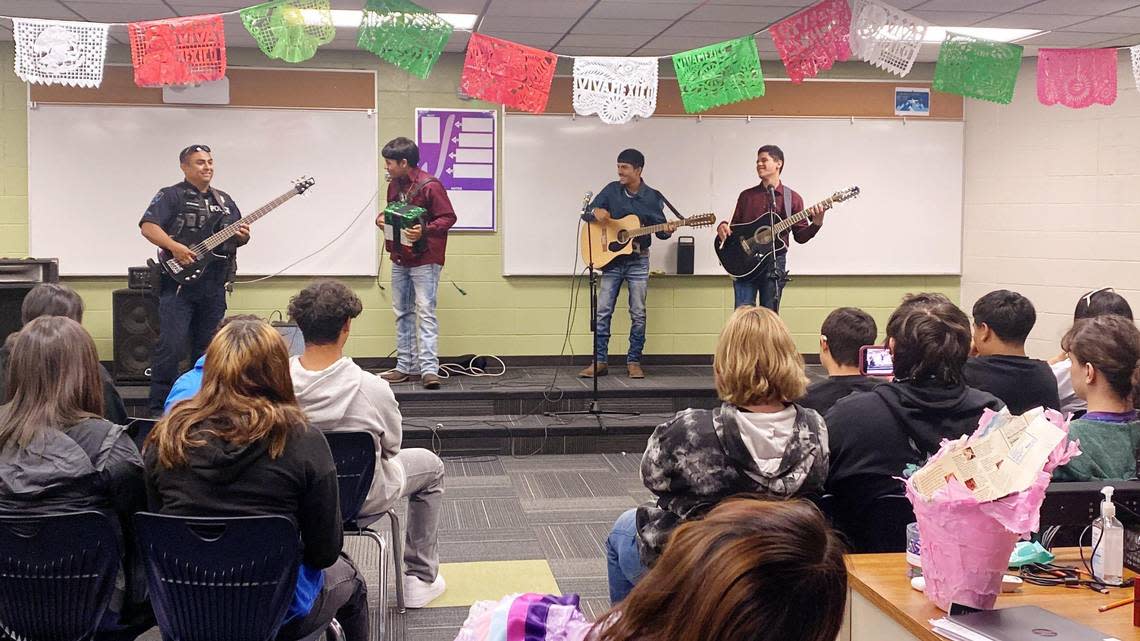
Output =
[{"x1": 503, "y1": 114, "x2": 964, "y2": 275}]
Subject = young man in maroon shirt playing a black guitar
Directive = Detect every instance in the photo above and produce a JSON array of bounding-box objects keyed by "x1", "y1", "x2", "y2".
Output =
[{"x1": 716, "y1": 145, "x2": 830, "y2": 314}]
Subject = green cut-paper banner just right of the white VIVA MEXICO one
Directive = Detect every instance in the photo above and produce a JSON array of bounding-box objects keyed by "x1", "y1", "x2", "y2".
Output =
[{"x1": 673, "y1": 35, "x2": 764, "y2": 114}]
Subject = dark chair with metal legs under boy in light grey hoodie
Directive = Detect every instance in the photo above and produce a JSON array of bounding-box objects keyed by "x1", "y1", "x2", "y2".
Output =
[{"x1": 325, "y1": 430, "x2": 407, "y2": 614}]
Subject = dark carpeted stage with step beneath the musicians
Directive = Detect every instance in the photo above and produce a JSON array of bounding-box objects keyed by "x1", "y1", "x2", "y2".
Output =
[{"x1": 119, "y1": 362, "x2": 824, "y2": 457}]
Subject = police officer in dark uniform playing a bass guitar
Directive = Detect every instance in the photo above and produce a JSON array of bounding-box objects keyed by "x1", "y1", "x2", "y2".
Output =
[{"x1": 139, "y1": 145, "x2": 250, "y2": 416}]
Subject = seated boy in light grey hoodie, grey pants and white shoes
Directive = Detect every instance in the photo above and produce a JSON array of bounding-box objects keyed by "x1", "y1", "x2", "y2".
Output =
[{"x1": 288, "y1": 281, "x2": 446, "y2": 608}]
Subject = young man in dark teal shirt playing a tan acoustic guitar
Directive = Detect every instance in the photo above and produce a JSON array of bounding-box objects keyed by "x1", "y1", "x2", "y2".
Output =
[{"x1": 578, "y1": 149, "x2": 677, "y2": 379}]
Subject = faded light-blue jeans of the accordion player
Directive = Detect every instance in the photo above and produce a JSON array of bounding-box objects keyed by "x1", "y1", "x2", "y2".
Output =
[{"x1": 392, "y1": 263, "x2": 443, "y2": 374}]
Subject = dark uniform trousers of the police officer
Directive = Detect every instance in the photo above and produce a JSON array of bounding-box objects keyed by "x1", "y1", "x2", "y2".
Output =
[{"x1": 147, "y1": 277, "x2": 226, "y2": 416}]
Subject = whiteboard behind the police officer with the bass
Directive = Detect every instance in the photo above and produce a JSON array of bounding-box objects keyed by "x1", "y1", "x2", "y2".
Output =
[{"x1": 27, "y1": 105, "x2": 380, "y2": 276}]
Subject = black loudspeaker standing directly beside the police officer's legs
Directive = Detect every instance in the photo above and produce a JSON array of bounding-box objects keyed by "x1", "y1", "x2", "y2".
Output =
[{"x1": 111, "y1": 290, "x2": 158, "y2": 382}]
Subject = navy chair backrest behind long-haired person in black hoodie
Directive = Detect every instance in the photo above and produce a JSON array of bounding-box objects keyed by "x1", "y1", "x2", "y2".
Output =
[{"x1": 135, "y1": 512, "x2": 301, "y2": 641}]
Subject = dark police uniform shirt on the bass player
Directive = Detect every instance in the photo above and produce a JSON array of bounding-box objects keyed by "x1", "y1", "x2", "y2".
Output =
[{"x1": 139, "y1": 180, "x2": 242, "y2": 284}]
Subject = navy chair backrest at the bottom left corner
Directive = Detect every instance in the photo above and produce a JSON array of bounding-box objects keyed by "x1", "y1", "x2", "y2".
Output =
[{"x1": 0, "y1": 511, "x2": 120, "y2": 641}]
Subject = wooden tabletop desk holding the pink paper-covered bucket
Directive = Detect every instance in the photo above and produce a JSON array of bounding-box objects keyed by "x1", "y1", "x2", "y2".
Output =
[{"x1": 839, "y1": 547, "x2": 1140, "y2": 641}]
